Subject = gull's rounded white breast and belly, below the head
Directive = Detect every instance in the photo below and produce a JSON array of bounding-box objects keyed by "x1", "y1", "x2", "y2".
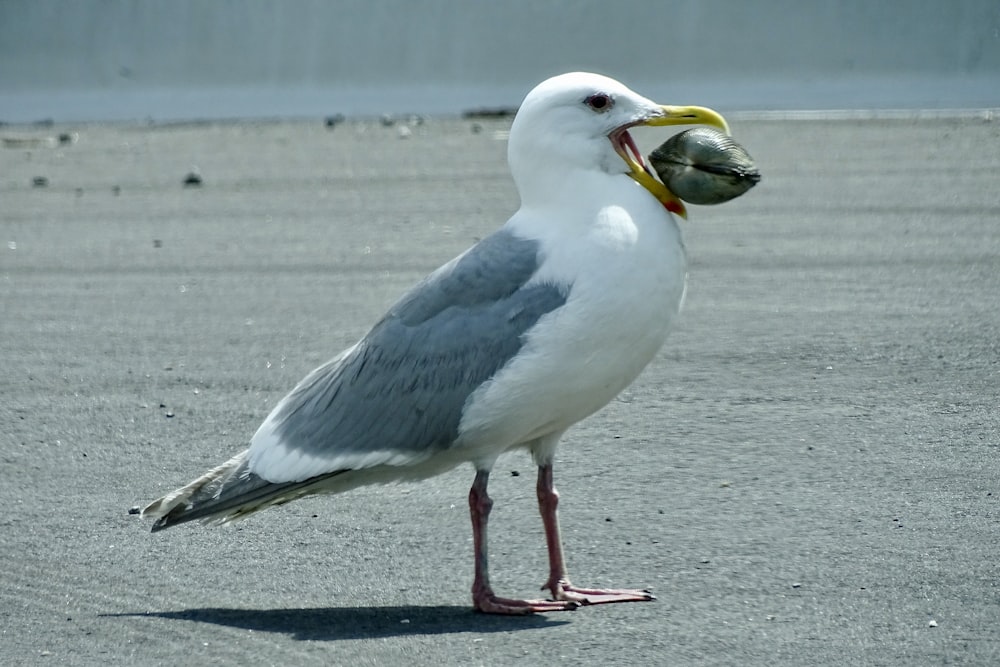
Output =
[{"x1": 459, "y1": 176, "x2": 687, "y2": 460}]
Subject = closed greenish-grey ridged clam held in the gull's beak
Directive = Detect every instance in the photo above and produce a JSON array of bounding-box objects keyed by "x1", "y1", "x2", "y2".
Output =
[{"x1": 649, "y1": 127, "x2": 760, "y2": 204}]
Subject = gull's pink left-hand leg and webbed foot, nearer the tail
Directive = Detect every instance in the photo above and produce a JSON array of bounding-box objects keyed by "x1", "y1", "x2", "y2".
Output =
[{"x1": 469, "y1": 470, "x2": 580, "y2": 614}]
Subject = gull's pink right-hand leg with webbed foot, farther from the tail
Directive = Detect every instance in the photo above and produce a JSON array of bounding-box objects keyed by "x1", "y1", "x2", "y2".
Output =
[{"x1": 538, "y1": 463, "x2": 656, "y2": 605}]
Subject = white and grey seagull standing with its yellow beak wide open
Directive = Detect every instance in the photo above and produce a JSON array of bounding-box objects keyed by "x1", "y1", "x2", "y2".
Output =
[{"x1": 142, "y1": 72, "x2": 728, "y2": 614}]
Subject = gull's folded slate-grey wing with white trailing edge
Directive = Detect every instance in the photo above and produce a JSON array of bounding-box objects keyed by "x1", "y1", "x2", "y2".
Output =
[{"x1": 250, "y1": 230, "x2": 570, "y2": 481}]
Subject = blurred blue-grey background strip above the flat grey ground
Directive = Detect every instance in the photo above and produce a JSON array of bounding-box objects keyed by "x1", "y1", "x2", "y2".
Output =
[{"x1": 0, "y1": 0, "x2": 1000, "y2": 122}]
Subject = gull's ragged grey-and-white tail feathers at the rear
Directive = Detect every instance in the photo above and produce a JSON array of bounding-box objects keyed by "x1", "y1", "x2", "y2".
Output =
[{"x1": 142, "y1": 450, "x2": 338, "y2": 532}]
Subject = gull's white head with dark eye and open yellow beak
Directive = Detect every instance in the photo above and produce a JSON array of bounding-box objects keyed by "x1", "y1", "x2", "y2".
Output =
[{"x1": 508, "y1": 72, "x2": 729, "y2": 217}]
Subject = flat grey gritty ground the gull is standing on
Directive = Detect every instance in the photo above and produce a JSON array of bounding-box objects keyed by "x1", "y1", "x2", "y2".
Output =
[{"x1": 0, "y1": 112, "x2": 1000, "y2": 665}]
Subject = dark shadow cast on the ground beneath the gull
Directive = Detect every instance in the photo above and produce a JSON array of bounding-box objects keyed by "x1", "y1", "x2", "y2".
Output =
[{"x1": 102, "y1": 606, "x2": 567, "y2": 641}]
